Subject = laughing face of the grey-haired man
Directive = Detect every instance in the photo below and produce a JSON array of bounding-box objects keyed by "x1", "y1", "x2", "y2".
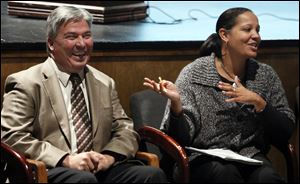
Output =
[{"x1": 48, "y1": 20, "x2": 93, "y2": 73}]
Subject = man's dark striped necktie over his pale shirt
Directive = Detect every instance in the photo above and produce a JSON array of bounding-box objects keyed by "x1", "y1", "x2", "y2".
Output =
[{"x1": 70, "y1": 74, "x2": 92, "y2": 153}]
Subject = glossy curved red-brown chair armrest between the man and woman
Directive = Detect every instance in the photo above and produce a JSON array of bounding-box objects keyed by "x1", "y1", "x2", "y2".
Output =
[{"x1": 137, "y1": 126, "x2": 189, "y2": 183}]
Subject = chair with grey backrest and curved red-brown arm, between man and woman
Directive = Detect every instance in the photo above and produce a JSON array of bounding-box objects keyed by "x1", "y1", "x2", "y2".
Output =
[{"x1": 130, "y1": 90, "x2": 189, "y2": 183}]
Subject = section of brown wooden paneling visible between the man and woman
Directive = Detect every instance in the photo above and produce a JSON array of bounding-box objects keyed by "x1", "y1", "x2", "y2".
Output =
[{"x1": 90, "y1": 50, "x2": 197, "y2": 116}]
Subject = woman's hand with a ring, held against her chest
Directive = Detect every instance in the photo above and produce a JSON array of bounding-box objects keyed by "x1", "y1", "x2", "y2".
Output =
[{"x1": 218, "y1": 76, "x2": 267, "y2": 112}]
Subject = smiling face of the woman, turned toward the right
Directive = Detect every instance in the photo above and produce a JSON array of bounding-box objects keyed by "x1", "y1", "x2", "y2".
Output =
[{"x1": 227, "y1": 12, "x2": 261, "y2": 59}]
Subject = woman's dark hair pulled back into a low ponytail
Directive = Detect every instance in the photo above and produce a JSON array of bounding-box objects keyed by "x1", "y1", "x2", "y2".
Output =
[{"x1": 200, "y1": 7, "x2": 252, "y2": 58}]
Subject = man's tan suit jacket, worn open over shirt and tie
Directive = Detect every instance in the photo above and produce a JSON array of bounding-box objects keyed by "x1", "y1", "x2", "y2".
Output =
[{"x1": 1, "y1": 58, "x2": 139, "y2": 167}]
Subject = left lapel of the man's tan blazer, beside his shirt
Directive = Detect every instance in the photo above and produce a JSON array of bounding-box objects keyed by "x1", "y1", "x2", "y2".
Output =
[{"x1": 42, "y1": 59, "x2": 71, "y2": 146}]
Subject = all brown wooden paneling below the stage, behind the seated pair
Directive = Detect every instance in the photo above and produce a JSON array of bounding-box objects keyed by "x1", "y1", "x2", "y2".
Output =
[{"x1": 1, "y1": 48, "x2": 299, "y2": 115}]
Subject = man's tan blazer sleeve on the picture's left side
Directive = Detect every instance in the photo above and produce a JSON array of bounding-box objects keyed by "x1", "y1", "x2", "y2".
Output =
[{"x1": 1, "y1": 71, "x2": 68, "y2": 167}]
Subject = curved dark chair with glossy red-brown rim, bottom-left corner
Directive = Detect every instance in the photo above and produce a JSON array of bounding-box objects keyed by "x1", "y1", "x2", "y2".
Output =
[{"x1": 1, "y1": 142, "x2": 33, "y2": 183}]
